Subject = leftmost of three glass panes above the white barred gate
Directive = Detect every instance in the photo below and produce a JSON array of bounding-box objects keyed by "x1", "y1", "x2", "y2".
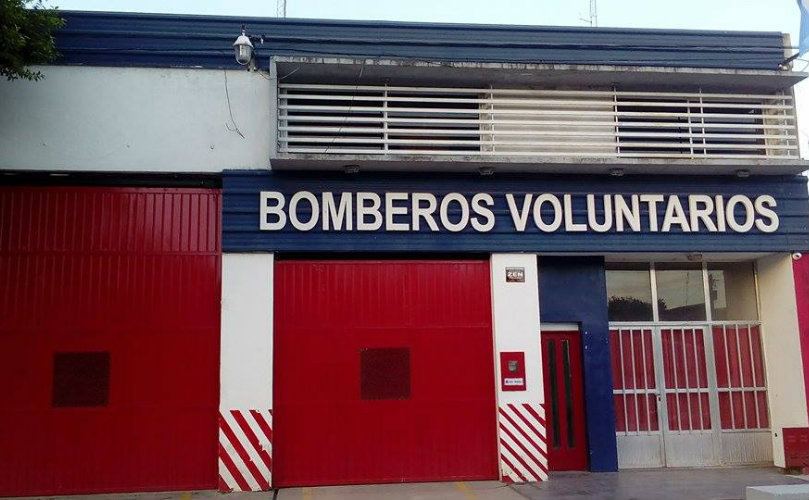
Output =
[{"x1": 607, "y1": 263, "x2": 654, "y2": 321}]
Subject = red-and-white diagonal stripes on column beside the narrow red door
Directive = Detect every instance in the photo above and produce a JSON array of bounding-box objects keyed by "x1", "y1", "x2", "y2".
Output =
[{"x1": 498, "y1": 403, "x2": 548, "y2": 483}]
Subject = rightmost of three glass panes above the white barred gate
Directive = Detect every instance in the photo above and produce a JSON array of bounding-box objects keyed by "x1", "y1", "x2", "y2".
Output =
[{"x1": 708, "y1": 262, "x2": 758, "y2": 321}]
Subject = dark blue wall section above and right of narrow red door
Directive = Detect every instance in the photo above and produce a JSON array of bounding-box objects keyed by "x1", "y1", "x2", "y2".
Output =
[{"x1": 539, "y1": 257, "x2": 618, "y2": 472}]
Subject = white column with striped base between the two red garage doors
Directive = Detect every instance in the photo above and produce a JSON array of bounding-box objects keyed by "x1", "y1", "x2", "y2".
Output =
[{"x1": 219, "y1": 253, "x2": 273, "y2": 491}]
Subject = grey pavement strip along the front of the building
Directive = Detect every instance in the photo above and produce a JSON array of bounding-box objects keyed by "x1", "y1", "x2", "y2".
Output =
[{"x1": 12, "y1": 467, "x2": 809, "y2": 500}]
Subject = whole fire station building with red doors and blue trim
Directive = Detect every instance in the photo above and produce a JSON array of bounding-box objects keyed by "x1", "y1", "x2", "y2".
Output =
[{"x1": 0, "y1": 12, "x2": 809, "y2": 495}]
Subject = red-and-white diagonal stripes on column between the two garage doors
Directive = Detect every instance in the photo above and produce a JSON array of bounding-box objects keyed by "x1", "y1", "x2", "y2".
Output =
[{"x1": 219, "y1": 410, "x2": 272, "y2": 492}]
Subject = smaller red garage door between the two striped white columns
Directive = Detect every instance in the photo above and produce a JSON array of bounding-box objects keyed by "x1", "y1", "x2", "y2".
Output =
[{"x1": 273, "y1": 260, "x2": 497, "y2": 486}]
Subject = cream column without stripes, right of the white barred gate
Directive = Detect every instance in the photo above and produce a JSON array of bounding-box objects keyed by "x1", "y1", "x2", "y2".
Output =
[{"x1": 756, "y1": 254, "x2": 809, "y2": 467}]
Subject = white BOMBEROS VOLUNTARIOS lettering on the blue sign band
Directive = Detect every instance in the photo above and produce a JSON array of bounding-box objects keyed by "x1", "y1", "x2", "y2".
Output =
[{"x1": 259, "y1": 191, "x2": 779, "y2": 233}]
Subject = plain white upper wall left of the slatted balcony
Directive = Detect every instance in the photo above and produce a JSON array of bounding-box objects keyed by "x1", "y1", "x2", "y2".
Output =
[{"x1": 0, "y1": 66, "x2": 275, "y2": 172}]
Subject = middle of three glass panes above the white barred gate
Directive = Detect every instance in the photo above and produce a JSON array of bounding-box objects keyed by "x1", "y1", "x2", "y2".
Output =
[{"x1": 655, "y1": 263, "x2": 706, "y2": 321}]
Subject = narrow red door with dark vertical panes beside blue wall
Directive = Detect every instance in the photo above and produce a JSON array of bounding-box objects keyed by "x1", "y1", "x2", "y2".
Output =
[{"x1": 542, "y1": 330, "x2": 587, "y2": 471}]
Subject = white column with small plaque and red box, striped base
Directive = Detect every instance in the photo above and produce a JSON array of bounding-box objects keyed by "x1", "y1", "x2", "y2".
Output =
[{"x1": 491, "y1": 254, "x2": 548, "y2": 482}]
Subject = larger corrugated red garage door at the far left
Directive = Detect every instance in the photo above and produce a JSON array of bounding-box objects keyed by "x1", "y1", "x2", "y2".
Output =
[{"x1": 0, "y1": 187, "x2": 221, "y2": 496}]
